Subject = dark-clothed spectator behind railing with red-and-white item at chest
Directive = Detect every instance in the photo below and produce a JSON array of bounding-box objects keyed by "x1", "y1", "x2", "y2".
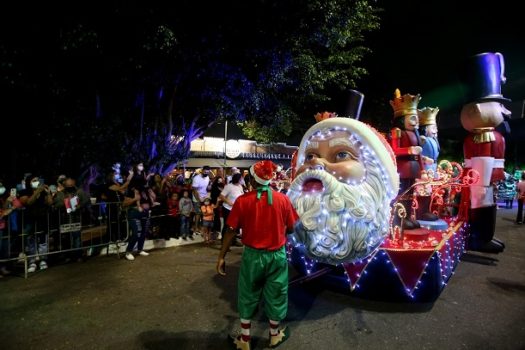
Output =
[{"x1": 53, "y1": 177, "x2": 89, "y2": 262}]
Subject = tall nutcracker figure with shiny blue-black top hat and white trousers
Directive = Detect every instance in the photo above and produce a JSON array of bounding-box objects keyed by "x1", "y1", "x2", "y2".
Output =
[{"x1": 461, "y1": 52, "x2": 510, "y2": 253}]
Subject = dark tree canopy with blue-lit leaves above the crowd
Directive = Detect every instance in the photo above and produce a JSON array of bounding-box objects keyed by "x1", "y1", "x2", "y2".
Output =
[{"x1": 0, "y1": 0, "x2": 379, "y2": 180}]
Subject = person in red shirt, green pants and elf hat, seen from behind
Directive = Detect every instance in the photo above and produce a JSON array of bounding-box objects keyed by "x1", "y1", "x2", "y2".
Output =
[{"x1": 217, "y1": 160, "x2": 299, "y2": 350}]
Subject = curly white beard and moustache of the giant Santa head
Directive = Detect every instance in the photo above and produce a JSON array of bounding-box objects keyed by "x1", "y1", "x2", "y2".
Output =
[{"x1": 288, "y1": 167, "x2": 391, "y2": 265}]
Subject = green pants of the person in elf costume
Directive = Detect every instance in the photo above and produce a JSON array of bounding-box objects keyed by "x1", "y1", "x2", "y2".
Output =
[{"x1": 237, "y1": 246, "x2": 288, "y2": 321}]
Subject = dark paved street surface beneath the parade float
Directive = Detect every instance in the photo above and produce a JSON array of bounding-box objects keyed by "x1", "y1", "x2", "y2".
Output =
[{"x1": 0, "y1": 207, "x2": 525, "y2": 350}]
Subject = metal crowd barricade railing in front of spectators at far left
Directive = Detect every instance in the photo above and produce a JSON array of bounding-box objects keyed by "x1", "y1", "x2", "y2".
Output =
[{"x1": 0, "y1": 202, "x2": 129, "y2": 278}]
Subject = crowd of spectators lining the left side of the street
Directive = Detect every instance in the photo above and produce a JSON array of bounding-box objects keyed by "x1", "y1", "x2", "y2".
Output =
[{"x1": 0, "y1": 163, "x2": 287, "y2": 278}]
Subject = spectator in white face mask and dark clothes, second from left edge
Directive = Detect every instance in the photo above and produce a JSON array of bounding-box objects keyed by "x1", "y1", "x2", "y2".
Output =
[{"x1": 19, "y1": 176, "x2": 52, "y2": 273}]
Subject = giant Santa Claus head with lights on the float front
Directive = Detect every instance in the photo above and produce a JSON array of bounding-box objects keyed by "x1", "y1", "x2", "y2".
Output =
[{"x1": 288, "y1": 118, "x2": 399, "y2": 265}]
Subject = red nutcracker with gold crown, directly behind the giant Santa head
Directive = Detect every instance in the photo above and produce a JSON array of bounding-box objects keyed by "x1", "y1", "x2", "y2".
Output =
[{"x1": 390, "y1": 89, "x2": 437, "y2": 230}]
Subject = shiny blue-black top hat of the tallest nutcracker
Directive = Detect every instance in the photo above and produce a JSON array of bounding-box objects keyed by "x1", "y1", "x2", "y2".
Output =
[{"x1": 460, "y1": 52, "x2": 510, "y2": 103}]
